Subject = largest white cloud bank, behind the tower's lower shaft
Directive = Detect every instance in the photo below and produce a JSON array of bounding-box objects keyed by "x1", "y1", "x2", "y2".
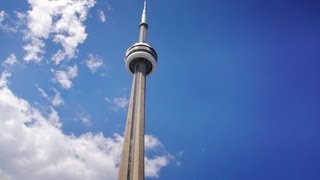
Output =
[{"x1": 0, "y1": 71, "x2": 169, "y2": 180}]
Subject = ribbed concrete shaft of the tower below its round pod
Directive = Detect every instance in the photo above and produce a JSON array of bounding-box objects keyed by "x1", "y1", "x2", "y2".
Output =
[{"x1": 118, "y1": 61, "x2": 146, "y2": 180}]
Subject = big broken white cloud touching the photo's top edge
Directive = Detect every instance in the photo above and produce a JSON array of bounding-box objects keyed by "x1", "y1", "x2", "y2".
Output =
[{"x1": 24, "y1": 0, "x2": 95, "y2": 64}]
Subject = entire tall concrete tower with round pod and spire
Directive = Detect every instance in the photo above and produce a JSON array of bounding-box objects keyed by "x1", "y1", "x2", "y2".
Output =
[{"x1": 118, "y1": 0, "x2": 158, "y2": 180}]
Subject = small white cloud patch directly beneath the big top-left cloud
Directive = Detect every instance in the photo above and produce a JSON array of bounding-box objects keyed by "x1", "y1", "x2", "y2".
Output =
[{"x1": 52, "y1": 65, "x2": 78, "y2": 89}]
